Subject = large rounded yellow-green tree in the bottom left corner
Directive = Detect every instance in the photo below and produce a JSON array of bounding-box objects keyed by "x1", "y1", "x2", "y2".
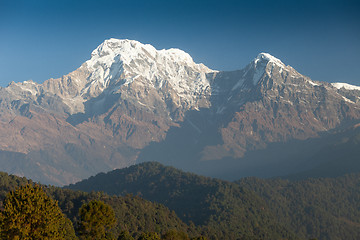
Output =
[{"x1": 0, "y1": 184, "x2": 76, "y2": 240}]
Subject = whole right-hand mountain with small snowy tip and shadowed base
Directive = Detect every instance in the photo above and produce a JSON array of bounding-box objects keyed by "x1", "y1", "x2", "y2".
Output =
[{"x1": 138, "y1": 53, "x2": 360, "y2": 180}]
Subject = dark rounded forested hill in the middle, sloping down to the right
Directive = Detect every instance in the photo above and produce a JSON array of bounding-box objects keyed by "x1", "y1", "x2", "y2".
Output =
[{"x1": 69, "y1": 162, "x2": 296, "y2": 239}]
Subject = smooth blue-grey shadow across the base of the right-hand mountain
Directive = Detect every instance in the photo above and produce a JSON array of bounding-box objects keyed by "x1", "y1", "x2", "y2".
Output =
[{"x1": 137, "y1": 109, "x2": 360, "y2": 180}]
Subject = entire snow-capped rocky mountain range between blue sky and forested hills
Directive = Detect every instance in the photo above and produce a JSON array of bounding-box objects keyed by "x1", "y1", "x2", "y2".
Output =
[{"x1": 0, "y1": 39, "x2": 360, "y2": 185}]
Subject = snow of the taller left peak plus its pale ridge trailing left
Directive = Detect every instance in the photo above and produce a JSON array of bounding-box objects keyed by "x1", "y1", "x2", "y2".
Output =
[{"x1": 7, "y1": 38, "x2": 217, "y2": 114}]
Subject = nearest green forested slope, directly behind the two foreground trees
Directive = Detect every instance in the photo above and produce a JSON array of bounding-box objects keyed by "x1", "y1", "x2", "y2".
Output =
[{"x1": 0, "y1": 172, "x2": 197, "y2": 239}]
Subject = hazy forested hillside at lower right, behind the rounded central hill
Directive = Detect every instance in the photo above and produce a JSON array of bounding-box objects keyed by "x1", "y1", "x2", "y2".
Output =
[{"x1": 237, "y1": 173, "x2": 360, "y2": 239}]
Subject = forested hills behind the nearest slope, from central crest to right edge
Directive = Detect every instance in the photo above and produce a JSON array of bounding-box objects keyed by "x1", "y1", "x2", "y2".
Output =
[{"x1": 69, "y1": 162, "x2": 360, "y2": 239}]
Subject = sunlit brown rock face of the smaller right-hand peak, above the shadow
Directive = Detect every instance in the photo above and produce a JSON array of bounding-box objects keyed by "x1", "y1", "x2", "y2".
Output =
[{"x1": 205, "y1": 54, "x2": 360, "y2": 159}]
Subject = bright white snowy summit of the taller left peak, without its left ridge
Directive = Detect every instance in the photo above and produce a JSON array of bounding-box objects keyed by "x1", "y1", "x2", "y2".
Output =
[{"x1": 82, "y1": 38, "x2": 216, "y2": 105}]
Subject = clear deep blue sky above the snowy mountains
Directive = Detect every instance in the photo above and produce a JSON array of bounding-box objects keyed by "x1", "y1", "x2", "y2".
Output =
[{"x1": 0, "y1": 0, "x2": 360, "y2": 86}]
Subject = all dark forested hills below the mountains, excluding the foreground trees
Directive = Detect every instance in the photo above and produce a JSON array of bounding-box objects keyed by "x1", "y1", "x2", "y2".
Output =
[{"x1": 0, "y1": 162, "x2": 360, "y2": 240}]
